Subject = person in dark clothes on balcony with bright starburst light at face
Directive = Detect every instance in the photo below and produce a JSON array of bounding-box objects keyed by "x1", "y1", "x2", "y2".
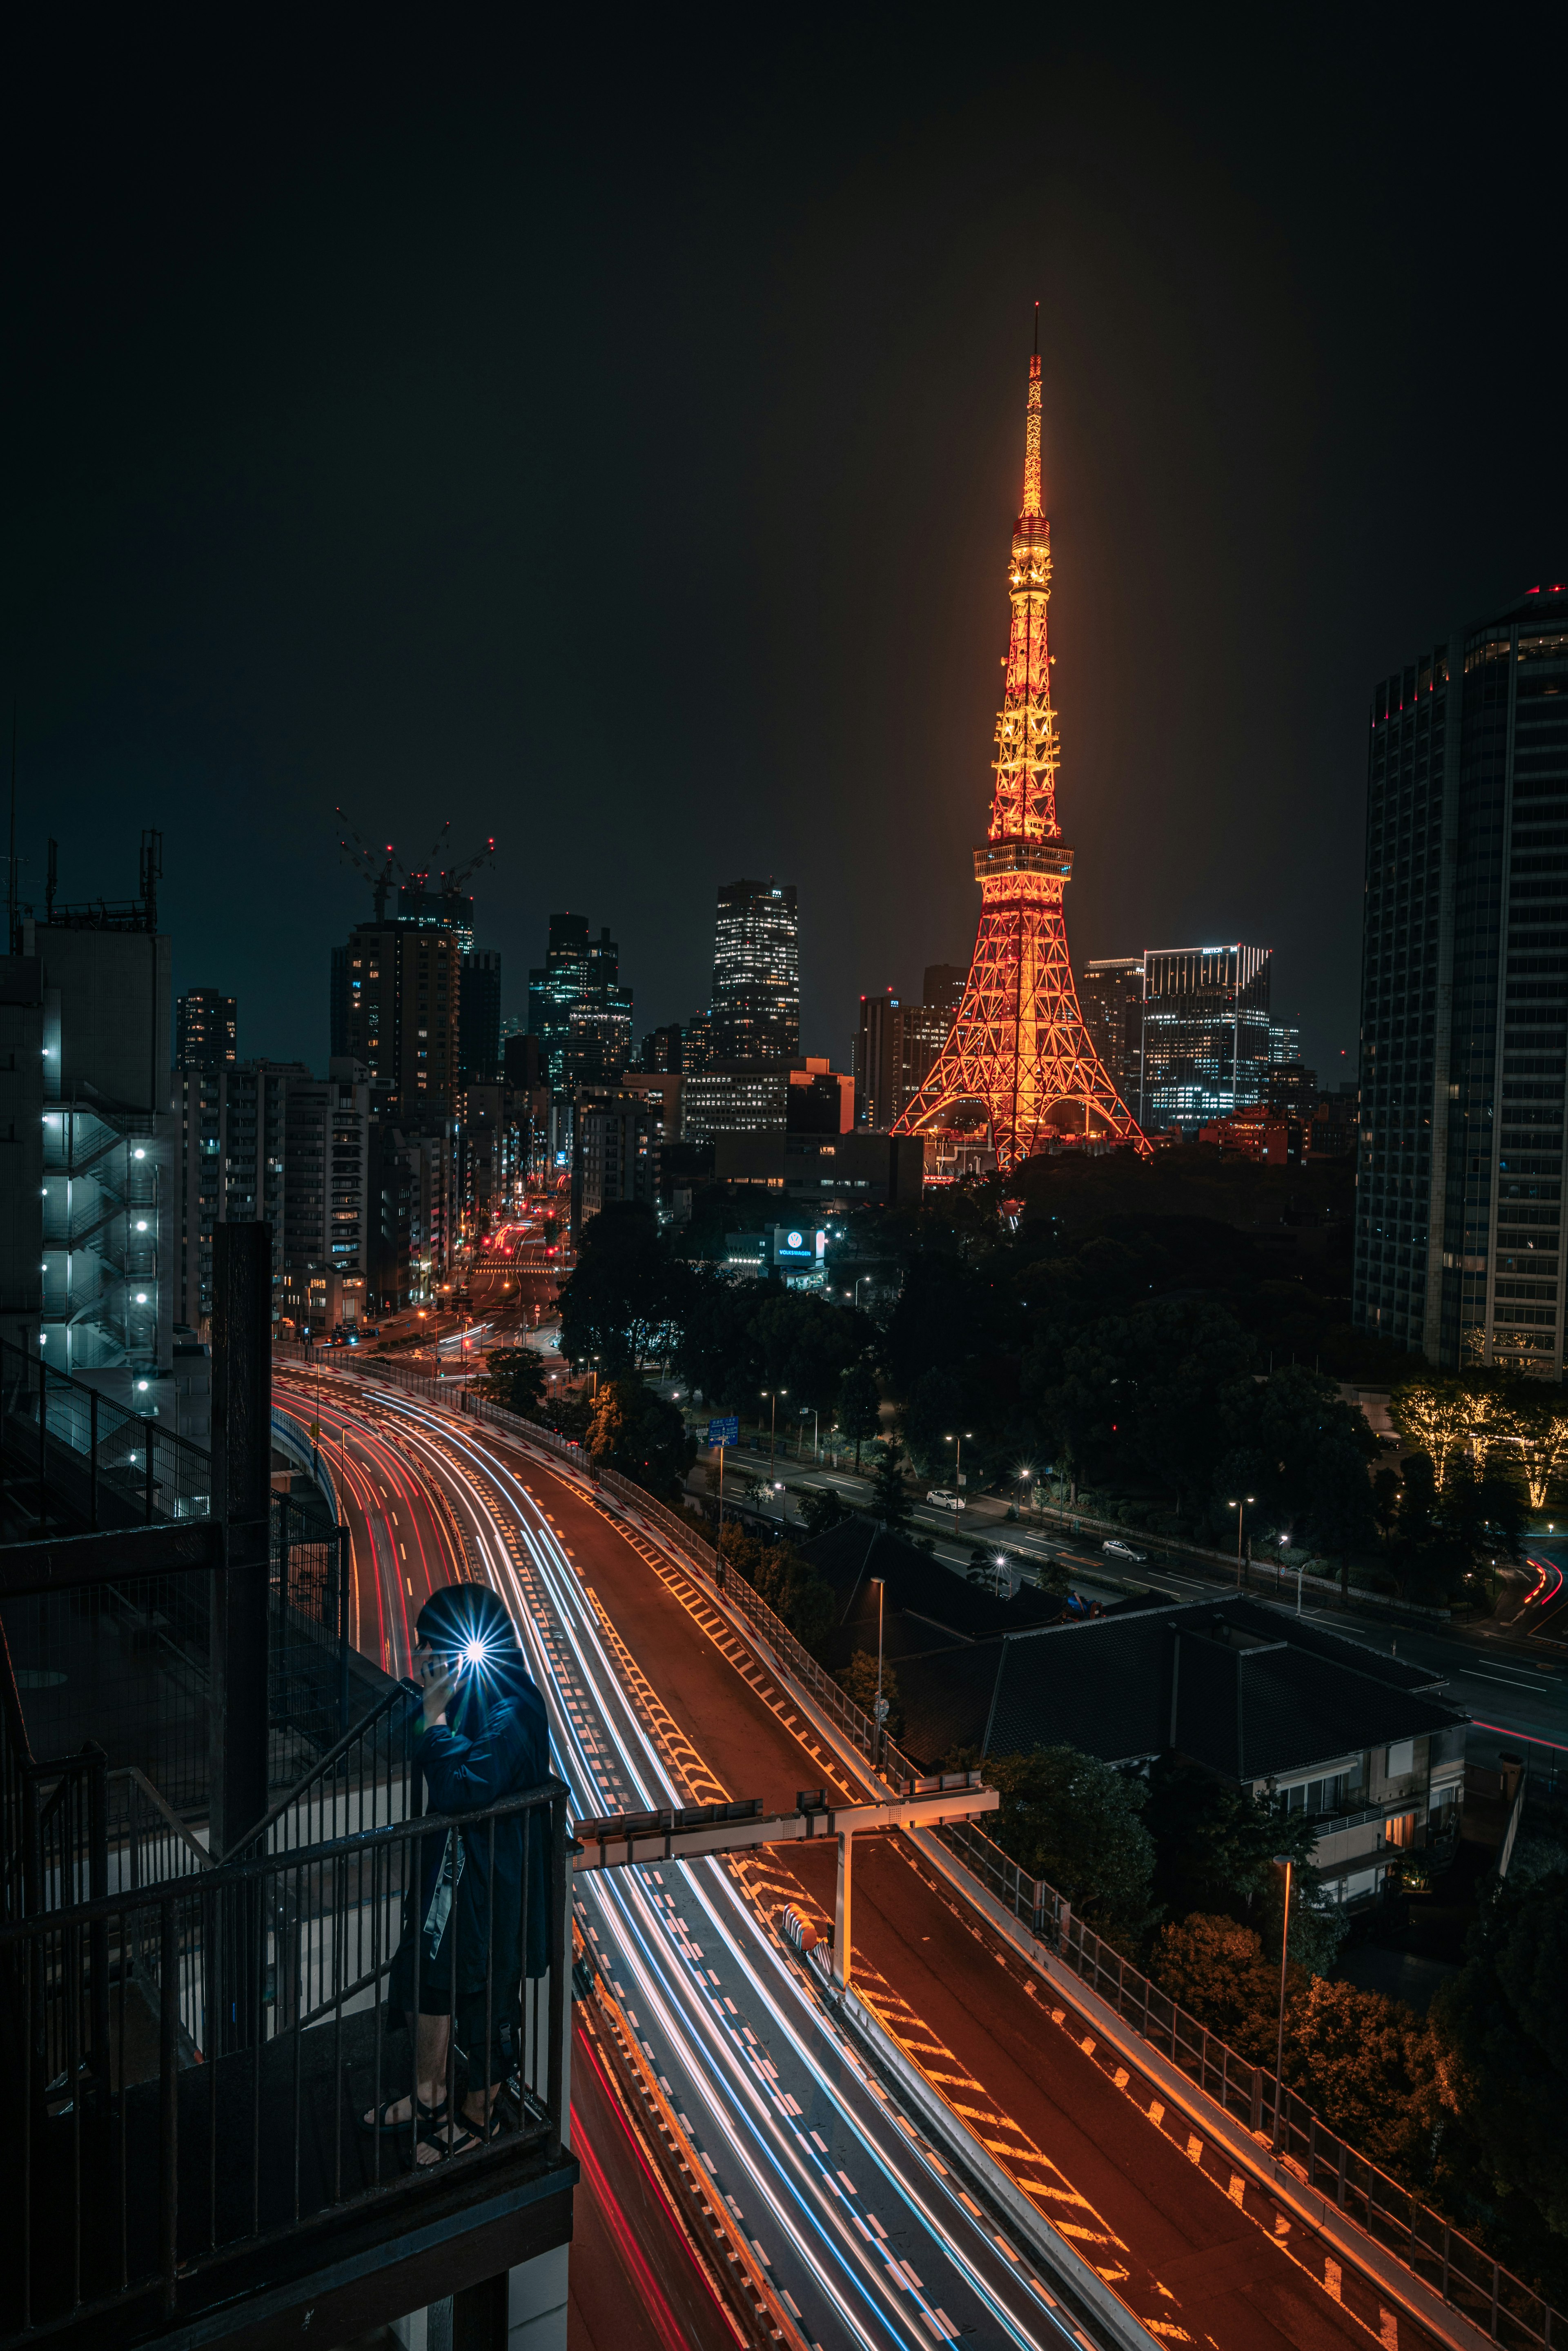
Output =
[{"x1": 362, "y1": 1584, "x2": 550, "y2": 2165}]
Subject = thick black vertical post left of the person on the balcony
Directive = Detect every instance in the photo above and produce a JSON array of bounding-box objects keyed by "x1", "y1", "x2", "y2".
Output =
[{"x1": 209, "y1": 1225, "x2": 273, "y2": 1855}]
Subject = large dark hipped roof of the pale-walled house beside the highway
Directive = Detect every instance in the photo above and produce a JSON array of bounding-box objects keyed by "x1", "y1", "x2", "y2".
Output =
[{"x1": 985, "y1": 1599, "x2": 1465, "y2": 1785}]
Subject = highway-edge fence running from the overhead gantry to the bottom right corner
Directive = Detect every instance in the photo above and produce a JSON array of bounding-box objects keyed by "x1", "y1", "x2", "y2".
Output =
[{"x1": 933, "y1": 1820, "x2": 1563, "y2": 2346}]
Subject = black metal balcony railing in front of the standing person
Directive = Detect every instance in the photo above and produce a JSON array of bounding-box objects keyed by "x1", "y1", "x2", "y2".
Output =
[{"x1": 0, "y1": 1780, "x2": 569, "y2": 2342}]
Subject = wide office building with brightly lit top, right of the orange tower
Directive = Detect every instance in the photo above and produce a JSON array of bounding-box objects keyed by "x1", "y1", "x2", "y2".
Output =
[{"x1": 1140, "y1": 945, "x2": 1274, "y2": 1131}]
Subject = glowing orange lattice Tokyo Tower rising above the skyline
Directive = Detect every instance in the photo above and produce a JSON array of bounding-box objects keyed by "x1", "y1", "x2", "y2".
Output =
[{"x1": 893, "y1": 317, "x2": 1149, "y2": 1176}]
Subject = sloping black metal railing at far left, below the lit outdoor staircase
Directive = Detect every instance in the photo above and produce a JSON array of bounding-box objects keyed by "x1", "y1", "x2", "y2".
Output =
[{"x1": 0, "y1": 1340, "x2": 212, "y2": 1531}]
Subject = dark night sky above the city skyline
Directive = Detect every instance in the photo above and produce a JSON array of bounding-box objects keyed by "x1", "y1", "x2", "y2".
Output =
[{"x1": 0, "y1": 9, "x2": 1568, "y2": 1074}]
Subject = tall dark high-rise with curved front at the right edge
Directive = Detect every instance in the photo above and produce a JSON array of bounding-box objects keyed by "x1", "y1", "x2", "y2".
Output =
[{"x1": 1352, "y1": 585, "x2": 1568, "y2": 1378}]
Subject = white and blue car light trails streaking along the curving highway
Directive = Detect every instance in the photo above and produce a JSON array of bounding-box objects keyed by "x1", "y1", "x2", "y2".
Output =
[{"x1": 291, "y1": 1392, "x2": 1105, "y2": 2351}]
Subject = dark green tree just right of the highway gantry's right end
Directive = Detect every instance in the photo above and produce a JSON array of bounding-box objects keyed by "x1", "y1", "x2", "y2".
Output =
[{"x1": 985, "y1": 1747, "x2": 1154, "y2": 1947}]
